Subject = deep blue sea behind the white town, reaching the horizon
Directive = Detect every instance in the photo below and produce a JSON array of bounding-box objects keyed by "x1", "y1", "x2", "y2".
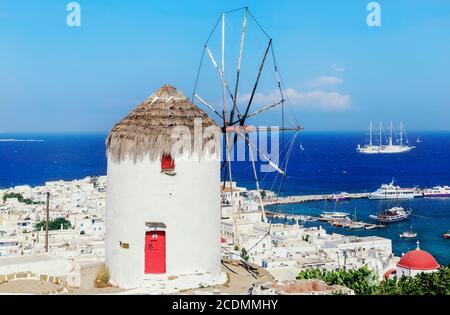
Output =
[{"x1": 0, "y1": 132, "x2": 450, "y2": 264}]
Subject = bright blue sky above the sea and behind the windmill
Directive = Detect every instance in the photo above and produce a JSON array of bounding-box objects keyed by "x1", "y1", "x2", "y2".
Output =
[{"x1": 0, "y1": 0, "x2": 450, "y2": 132}]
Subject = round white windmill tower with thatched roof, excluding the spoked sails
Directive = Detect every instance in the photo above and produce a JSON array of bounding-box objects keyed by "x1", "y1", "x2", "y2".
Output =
[{"x1": 106, "y1": 85, "x2": 226, "y2": 289}]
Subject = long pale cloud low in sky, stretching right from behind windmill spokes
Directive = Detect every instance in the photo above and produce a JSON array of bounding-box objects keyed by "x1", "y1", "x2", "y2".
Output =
[{"x1": 238, "y1": 88, "x2": 351, "y2": 111}]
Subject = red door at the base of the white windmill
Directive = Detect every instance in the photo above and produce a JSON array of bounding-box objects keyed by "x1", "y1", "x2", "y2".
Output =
[{"x1": 144, "y1": 231, "x2": 166, "y2": 274}]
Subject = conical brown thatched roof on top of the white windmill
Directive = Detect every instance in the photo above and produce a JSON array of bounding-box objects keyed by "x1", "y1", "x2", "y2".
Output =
[{"x1": 106, "y1": 85, "x2": 220, "y2": 162}]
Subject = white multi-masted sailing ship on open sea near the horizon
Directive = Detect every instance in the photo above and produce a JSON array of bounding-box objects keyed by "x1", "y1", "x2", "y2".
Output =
[{"x1": 356, "y1": 122, "x2": 415, "y2": 154}]
